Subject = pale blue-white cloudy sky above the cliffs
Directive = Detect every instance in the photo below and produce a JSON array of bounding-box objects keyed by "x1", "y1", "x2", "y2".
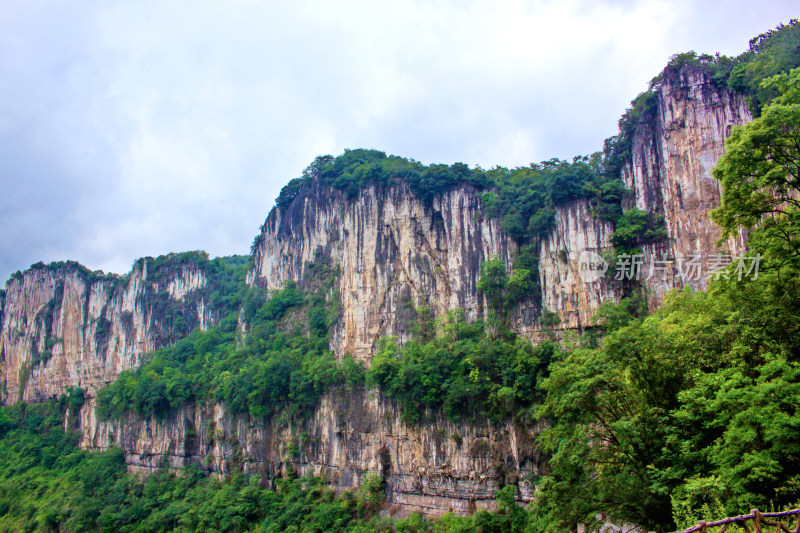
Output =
[{"x1": 0, "y1": 0, "x2": 798, "y2": 285}]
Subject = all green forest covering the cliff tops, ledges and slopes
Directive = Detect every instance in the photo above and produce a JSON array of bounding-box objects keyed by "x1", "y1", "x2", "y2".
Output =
[{"x1": 0, "y1": 18, "x2": 800, "y2": 532}]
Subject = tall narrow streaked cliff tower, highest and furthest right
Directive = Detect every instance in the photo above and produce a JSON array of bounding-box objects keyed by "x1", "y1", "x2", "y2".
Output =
[{"x1": 622, "y1": 66, "x2": 752, "y2": 303}]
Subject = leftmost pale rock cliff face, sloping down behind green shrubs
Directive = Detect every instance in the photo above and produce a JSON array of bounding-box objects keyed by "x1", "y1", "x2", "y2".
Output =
[{"x1": 0, "y1": 259, "x2": 219, "y2": 403}]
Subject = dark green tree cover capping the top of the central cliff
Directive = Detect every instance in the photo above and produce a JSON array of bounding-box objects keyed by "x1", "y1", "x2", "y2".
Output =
[{"x1": 276, "y1": 149, "x2": 623, "y2": 228}]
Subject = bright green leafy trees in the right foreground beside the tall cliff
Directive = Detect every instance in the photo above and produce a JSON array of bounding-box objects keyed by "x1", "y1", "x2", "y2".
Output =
[{"x1": 536, "y1": 70, "x2": 800, "y2": 531}]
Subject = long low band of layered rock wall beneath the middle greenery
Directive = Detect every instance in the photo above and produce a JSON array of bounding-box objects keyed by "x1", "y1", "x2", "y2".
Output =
[{"x1": 81, "y1": 390, "x2": 541, "y2": 515}]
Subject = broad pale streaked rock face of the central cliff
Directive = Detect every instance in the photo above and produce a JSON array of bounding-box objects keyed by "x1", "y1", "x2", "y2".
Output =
[{"x1": 248, "y1": 181, "x2": 515, "y2": 360}]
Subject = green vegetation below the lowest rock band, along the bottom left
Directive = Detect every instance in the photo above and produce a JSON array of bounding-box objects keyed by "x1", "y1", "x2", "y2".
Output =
[{"x1": 0, "y1": 402, "x2": 527, "y2": 533}]
